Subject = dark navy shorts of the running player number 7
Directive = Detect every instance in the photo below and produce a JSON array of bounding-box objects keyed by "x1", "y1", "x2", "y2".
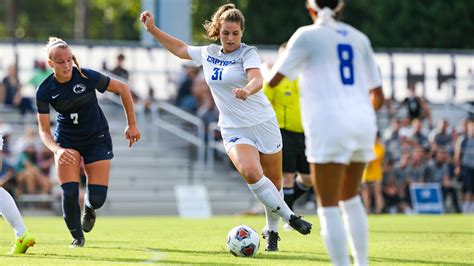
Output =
[{"x1": 58, "y1": 132, "x2": 114, "y2": 164}]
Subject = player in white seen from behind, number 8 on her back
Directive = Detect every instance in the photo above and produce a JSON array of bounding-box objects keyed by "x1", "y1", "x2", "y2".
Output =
[{"x1": 269, "y1": 0, "x2": 383, "y2": 265}]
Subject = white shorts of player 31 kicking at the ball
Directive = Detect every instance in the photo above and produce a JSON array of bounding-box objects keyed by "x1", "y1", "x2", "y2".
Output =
[{"x1": 221, "y1": 117, "x2": 283, "y2": 154}]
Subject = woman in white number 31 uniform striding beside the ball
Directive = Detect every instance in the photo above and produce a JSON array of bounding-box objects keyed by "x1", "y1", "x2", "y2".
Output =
[{"x1": 140, "y1": 4, "x2": 311, "y2": 251}]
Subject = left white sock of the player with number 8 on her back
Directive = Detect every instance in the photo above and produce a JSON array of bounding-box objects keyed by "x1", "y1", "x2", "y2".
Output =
[{"x1": 318, "y1": 207, "x2": 350, "y2": 266}]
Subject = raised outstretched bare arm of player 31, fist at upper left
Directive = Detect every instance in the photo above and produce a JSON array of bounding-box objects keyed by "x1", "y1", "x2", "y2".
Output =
[{"x1": 140, "y1": 11, "x2": 191, "y2": 60}]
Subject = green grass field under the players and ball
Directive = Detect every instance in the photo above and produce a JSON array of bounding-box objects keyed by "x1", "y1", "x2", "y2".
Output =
[{"x1": 0, "y1": 213, "x2": 474, "y2": 265}]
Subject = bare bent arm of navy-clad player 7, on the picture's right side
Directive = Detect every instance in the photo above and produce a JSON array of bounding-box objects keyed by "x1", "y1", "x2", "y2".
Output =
[{"x1": 107, "y1": 78, "x2": 140, "y2": 147}]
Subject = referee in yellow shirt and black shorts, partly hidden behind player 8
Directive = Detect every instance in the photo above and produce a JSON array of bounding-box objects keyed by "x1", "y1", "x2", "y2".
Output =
[{"x1": 263, "y1": 43, "x2": 311, "y2": 214}]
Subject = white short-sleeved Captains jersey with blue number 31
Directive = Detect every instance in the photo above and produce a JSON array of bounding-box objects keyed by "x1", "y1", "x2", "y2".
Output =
[{"x1": 188, "y1": 44, "x2": 275, "y2": 128}]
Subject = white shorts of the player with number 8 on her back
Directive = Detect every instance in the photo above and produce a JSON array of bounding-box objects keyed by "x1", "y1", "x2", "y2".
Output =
[{"x1": 305, "y1": 111, "x2": 377, "y2": 164}]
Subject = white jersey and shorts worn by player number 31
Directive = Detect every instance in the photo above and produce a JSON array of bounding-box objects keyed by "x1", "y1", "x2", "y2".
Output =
[{"x1": 188, "y1": 44, "x2": 282, "y2": 154}]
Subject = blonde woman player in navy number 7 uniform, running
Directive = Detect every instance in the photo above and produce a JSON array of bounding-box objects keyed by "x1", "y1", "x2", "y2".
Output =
[{"x1": 36, "y1": 37, "x2": 140, "y2": 248}]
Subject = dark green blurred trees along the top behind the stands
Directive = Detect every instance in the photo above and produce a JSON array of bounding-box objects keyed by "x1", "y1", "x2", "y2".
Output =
[{"x1": 0, "y1": 0, "x2": 474, "y2": 49}]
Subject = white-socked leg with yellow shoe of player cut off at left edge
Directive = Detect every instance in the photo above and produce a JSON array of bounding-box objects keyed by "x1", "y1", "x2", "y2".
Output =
[{"x1": 0, "y1": 135, "x2": 35, "y2": 255}]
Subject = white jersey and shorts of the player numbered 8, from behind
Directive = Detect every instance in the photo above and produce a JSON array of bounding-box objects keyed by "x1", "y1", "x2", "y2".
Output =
[{"x1": 274, "y1": 18, "x2": 381, "y2": 163}]
